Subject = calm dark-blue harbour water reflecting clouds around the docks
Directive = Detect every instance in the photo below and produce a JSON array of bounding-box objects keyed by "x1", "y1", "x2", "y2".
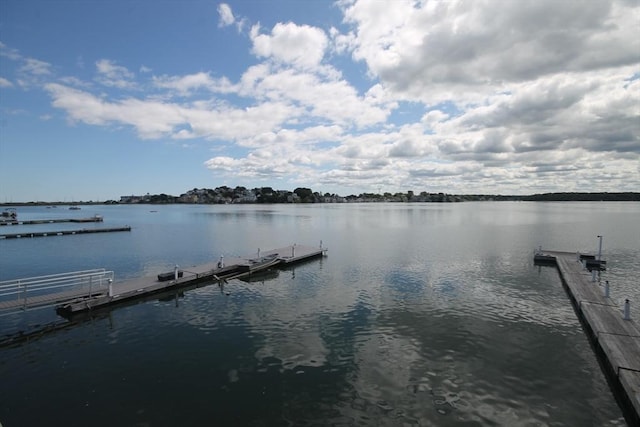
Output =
[{"x1": 0, "y1": 202, "x2": 640, "y2": 427}]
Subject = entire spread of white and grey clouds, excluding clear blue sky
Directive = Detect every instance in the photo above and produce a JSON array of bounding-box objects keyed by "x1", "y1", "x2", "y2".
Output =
[{"x1": 0, "y1": 0, "x2": 640, "y2": 193}]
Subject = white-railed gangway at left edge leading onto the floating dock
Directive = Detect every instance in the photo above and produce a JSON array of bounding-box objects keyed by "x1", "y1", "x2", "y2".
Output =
[{"x1": 0, "y1": 268, "x2": 113, "y2": 308}]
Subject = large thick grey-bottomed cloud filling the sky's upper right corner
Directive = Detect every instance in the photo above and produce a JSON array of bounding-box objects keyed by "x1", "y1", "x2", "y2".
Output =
[{"x1": 344, "y1": 0, "x2": 640, "y2": 102}]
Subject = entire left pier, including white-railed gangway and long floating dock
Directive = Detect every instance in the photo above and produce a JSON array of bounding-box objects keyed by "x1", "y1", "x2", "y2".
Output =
[{"x1": 0, "y1": 245, "x2": 327, "y2": 317}]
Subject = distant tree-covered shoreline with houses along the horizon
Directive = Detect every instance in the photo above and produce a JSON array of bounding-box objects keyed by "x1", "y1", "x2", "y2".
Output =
[{"x1": 0, "y1": 186, "x2": 640, "y2": 206}]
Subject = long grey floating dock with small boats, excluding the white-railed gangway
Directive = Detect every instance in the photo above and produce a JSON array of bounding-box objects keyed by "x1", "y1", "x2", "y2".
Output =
[{"x1": 57, "y1": 245, "x2": 327, "y2": 317}]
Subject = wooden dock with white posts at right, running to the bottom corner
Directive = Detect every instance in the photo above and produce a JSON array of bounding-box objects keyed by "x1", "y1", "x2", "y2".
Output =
[{"x1": 534, "y1": 250, "x2": 640, "y2": 426}]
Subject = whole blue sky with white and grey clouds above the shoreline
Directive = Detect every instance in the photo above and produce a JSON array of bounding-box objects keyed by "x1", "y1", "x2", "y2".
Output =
[{"x1": 0, "y1": 0, "x2": 640, "y2": 203}]
